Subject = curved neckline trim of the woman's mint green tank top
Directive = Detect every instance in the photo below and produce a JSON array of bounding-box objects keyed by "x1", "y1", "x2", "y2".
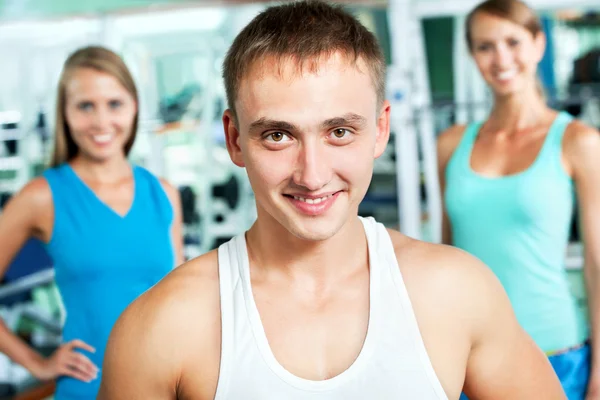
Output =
[{"x1": 464, "y1": 111, "x2": 569, "y2": 183}]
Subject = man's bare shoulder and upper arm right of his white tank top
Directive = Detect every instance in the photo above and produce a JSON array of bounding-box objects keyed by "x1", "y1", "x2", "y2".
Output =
[{"x1": 390, "y1": 231, "x2": 566, "y2": 400}]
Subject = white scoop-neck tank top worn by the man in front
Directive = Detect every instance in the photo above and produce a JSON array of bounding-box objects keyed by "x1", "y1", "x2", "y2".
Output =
[{"x1": 215, "y1": 218, "x2": 447, "y2": 400}]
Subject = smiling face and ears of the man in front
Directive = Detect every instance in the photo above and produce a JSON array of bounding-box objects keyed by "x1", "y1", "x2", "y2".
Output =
[{"x1": 223, "y1": 54, "x2": 390, "y2": 241}]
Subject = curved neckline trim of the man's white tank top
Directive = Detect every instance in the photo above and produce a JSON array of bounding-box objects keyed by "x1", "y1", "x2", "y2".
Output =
[{"x1": 236, "y1": 217, "x2": 382, "y2": 392}]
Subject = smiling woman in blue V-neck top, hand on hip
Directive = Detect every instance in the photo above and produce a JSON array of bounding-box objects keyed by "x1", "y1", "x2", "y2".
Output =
[{"x1": 0, "y1": 47, "x2": 182, "y2": 400}]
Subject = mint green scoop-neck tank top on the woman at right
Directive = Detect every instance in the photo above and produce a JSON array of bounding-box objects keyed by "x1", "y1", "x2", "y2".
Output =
[{"x1": 444, "y1": 113, "x2": 588, "y2": 352}]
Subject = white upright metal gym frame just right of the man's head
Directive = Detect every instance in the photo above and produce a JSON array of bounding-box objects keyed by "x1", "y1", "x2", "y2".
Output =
[{"x1": 387, "y1": 0, "x2": 441, "y2": 242}]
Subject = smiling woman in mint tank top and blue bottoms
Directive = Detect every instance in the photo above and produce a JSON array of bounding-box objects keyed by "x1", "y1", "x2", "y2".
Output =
[{"x1": 438, "y1": 0, "x2": 600, "y2": 399}]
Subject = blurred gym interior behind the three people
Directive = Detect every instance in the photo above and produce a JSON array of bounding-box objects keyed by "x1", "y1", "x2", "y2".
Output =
[{"x1": 0, "y1": 0, "x2": 600, "y2": 399}]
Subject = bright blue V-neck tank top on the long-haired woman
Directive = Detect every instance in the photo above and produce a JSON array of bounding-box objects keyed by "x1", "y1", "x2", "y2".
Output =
[{"x1": 43, "y1": 164, "x2": 175, "y2": 400}]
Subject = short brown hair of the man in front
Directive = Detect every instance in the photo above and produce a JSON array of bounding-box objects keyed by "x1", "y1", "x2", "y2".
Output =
[{"x1": 223, "y1": 0, "x2": 385, "y2": 115}]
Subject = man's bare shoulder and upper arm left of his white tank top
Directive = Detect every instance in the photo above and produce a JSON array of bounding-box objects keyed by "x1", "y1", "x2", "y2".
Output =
[{"x1": 100, "y1": 251, "x2": 221, "y2": 399}]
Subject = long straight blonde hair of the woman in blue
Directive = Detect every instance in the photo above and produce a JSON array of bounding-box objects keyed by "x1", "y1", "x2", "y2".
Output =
[{"x1": 50, "y1": 46, "x2": 139, "y2": 167}]
